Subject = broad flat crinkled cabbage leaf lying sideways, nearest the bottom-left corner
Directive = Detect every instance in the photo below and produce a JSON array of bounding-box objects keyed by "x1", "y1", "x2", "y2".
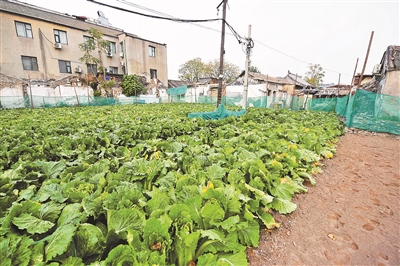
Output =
[{"x1": 12, "y1": 213, "x2": 54, "y2": 234}]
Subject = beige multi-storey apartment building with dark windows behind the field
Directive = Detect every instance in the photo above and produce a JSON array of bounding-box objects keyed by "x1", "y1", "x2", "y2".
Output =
[{"x1": 0, "y1": 0, "x2": 168, "y2": 86}]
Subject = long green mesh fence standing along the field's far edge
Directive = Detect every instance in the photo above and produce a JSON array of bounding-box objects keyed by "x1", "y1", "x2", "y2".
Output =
[{"x1": 0, "y1": 90, "x2": 400, "y2": 135}]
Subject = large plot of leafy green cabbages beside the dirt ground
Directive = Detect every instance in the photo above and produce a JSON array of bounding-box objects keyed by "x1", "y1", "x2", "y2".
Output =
[{"x1": 0, "y1": 104, "x2": 344, "y2": 265}]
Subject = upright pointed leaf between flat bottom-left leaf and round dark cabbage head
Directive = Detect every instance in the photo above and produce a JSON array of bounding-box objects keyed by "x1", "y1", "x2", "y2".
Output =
[{"x1": 45, "y1": 224, "x2": 76, "y2": 261}]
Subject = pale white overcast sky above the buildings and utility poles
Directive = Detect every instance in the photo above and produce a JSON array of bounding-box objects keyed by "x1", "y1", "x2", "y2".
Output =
[{"x1": 20, "y1": 0, "x2": 400, "y2": 84}]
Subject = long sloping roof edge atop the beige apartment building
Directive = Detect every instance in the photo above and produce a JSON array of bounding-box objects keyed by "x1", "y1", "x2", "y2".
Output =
[{"x1": 0, "y1": 0, "x2": 124, "y2": 37}]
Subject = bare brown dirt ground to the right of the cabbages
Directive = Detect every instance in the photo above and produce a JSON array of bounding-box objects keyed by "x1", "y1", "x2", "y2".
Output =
[{"x1": 247, "y1": 130, "x2": 400, "y2": 266}]
